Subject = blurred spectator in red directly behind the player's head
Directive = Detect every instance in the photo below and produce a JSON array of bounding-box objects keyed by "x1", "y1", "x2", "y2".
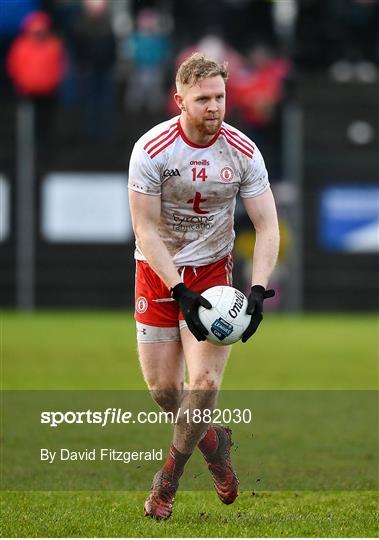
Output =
[{"x1": 168, "y1": 34, "x2": 244, "y2": 115}]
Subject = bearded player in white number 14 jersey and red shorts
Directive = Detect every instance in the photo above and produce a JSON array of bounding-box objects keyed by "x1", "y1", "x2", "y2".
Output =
[{"x1": 129, "y1": 53, "x2": 279, "y2": 520}]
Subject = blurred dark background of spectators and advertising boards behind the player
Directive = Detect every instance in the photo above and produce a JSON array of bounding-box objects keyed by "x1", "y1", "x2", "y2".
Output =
[{"x1": 0, "y1": 0, "x2": 379, "y2": 311}]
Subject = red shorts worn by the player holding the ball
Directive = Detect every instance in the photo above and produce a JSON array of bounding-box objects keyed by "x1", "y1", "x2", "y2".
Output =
[{"x1": 134, "y1": 255, "x2": 233, "y2": 327}]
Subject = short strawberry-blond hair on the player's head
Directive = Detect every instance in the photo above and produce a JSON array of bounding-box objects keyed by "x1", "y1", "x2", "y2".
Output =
[{"x1": 175, "y1": 52, "x2": 229, "y2": 91}]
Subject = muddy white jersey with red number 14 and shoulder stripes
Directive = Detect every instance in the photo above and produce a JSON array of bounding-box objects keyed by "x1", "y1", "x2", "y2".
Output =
[{"x1": 128, "y1": 116, "x2": 270, "y2": 267}]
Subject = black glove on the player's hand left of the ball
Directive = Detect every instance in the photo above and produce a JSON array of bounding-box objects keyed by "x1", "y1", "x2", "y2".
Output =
[{"x1": 171, "y1": 283, "x2": 212, "y2": 341}]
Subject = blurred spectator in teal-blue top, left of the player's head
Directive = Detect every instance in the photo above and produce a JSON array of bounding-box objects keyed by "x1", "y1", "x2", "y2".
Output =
[{"x1": 125, "y1": 9, "x2": 171, "y2": 113}]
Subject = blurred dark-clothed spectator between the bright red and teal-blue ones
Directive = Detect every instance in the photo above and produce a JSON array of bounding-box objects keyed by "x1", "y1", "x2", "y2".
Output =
[{"x1": 73, "y1": 0, "x2": 116, "y2": 142}]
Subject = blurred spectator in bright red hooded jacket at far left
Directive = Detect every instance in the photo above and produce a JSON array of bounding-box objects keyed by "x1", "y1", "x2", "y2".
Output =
[{"x1": 7, "y1": 11, "x2": 65, "y2": 141}]
